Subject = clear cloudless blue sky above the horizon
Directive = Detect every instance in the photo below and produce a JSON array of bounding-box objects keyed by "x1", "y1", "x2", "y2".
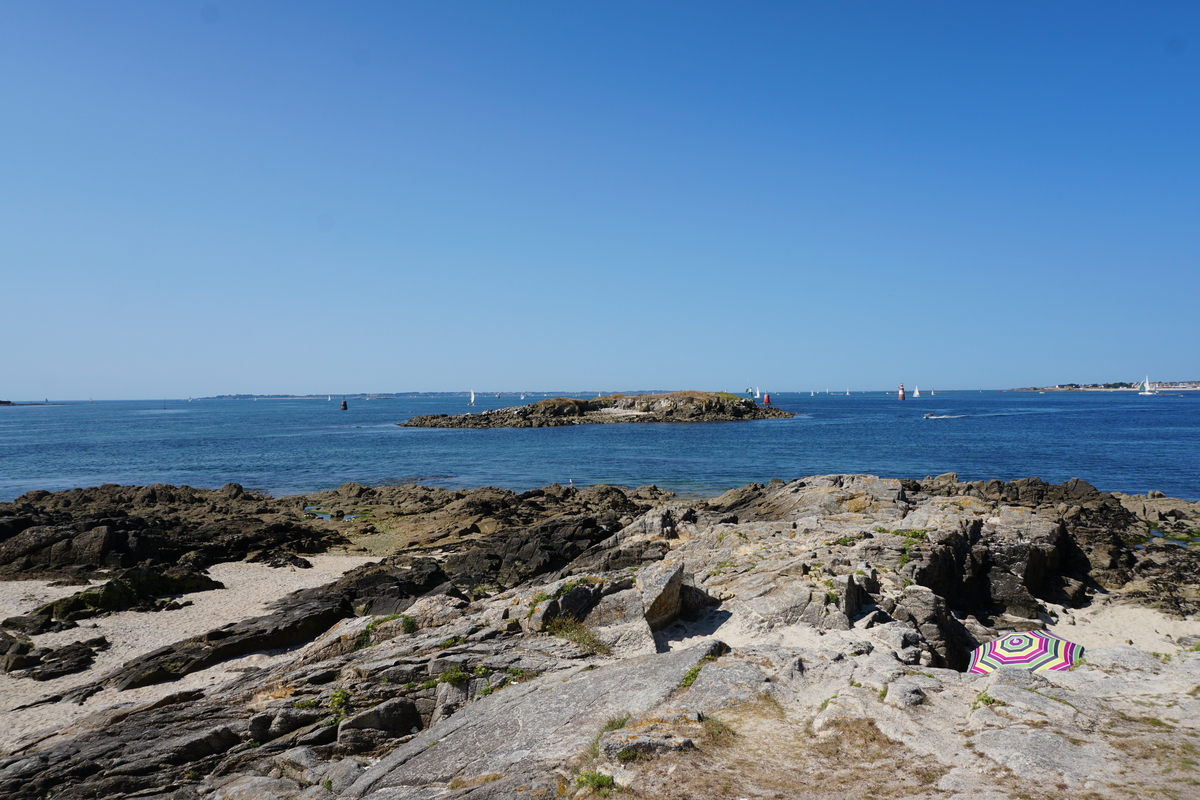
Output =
[{"x1": 0, "y1": 0, "x2": 1200, "y2": 399}]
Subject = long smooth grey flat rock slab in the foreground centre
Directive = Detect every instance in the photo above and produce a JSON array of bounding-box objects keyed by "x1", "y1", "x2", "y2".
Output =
[{"x1": 343, "y1": 640, "x2": 725, "y2": 800}]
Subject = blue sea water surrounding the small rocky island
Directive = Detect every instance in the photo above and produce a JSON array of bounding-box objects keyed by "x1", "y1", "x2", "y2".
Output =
[{"x1": 0, "y1": 392, "x2": 1200, "y2": 500}]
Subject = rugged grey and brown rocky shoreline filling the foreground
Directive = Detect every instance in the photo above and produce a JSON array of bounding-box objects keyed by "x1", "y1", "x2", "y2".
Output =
[{"x1": 0, "y1": 475, "x2": 1200, "y2": 800}]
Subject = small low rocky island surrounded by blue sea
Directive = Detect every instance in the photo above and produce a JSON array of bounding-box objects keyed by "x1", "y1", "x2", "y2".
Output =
[{"x1": 397, "y1": 391, "x2": 796, "y2": 428}]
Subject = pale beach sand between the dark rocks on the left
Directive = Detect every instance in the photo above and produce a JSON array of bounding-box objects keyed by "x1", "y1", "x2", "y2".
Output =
[{"x1": 0, "y1": 555, "x2": 378, "y2": 754}]
